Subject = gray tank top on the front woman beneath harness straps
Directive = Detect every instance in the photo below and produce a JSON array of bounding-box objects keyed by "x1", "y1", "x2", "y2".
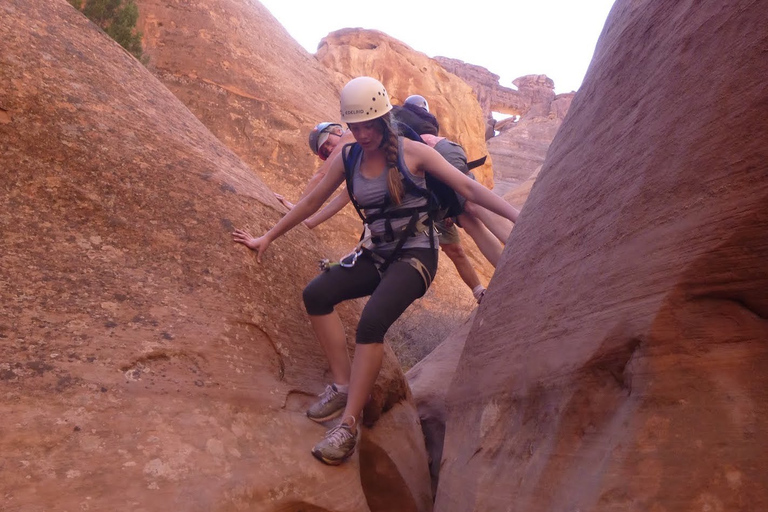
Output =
[{"x1": 352, "y1": 137, "x2": 438, "y2": 257}]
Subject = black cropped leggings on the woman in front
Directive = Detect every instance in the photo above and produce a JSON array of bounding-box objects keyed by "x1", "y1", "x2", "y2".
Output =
[{"x1": 304, "y1": 249, "x2": 437, "y2": 344}]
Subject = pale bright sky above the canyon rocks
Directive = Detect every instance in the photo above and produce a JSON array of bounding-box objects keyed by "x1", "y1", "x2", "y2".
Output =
[{"x1": 261, "y1": 0, "x2": 614, "y2": 93}]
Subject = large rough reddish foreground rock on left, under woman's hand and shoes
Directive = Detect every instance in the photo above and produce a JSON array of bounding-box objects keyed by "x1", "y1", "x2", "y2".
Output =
[{"x1": 0, "y1": 0, "x2": 431, "y2": 512}]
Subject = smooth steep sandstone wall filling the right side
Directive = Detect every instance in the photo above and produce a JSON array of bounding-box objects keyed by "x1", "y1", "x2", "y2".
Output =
[{"x1": 435, "y1": 0, "x2": 768, "y2": 512}]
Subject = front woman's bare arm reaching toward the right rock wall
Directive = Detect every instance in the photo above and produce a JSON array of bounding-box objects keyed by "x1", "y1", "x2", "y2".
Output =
[{"x1": 404, "y1": 140, "x2": 520, "y2": 222}]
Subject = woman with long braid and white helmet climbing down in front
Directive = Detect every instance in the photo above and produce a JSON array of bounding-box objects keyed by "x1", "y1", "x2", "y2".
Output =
[{"x1": 232, "y1": 77, "x2": 518, "y2": 465}]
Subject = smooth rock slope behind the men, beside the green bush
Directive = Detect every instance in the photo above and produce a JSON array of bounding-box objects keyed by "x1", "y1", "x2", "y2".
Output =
[{"x1": 137, "y1": 0, "x2": 339, "y2": 204}]
